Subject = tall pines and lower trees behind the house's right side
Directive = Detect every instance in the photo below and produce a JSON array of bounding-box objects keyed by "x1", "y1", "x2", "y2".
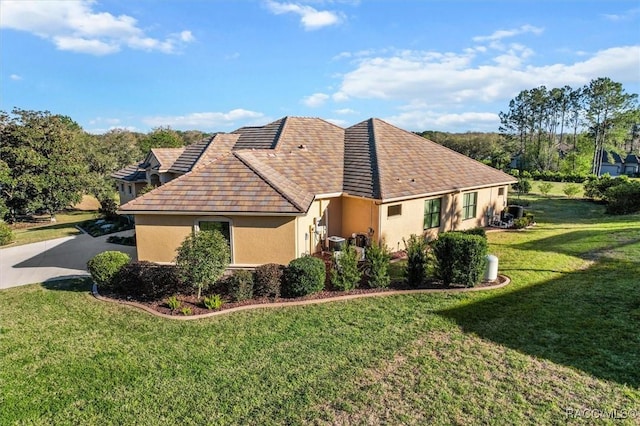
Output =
[{"x1": 419, "y1": 77, "x2": 640, "y2": 175}]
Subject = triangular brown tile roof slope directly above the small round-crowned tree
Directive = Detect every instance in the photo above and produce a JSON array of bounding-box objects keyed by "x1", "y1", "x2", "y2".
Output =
[{"x1": 120, "y1": 153, "x2": 310, "y2": 214}]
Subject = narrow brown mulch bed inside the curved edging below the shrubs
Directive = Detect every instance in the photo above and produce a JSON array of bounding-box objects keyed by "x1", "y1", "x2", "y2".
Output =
[{"x1": 100, "y1": 275, "x2": 506, "y2": 316}]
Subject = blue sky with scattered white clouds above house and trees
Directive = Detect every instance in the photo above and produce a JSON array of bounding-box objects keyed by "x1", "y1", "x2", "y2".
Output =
[{"x1": 0, "y1": 0, "x2": 640, "y2": 133}]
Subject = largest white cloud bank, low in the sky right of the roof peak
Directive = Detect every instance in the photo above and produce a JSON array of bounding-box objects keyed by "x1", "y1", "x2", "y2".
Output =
[{"x1": 332, "y1": 46, "x2": 640, "y2": 107}]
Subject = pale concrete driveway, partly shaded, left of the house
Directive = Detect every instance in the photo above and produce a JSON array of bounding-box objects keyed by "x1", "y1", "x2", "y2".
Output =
[{"x1": 0, "y1": 230, "x2": 136, "y2": 289}]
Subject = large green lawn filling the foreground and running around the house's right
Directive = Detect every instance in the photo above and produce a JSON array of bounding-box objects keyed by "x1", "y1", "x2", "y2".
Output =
[{"x1": 0, "y1": 196, "x2": 640, "y2": 425}]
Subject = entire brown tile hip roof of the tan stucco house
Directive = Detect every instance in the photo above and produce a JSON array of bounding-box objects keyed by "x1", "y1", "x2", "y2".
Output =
[{"x1": 120, "y1": 117, "x2": 515, "y2": 214}]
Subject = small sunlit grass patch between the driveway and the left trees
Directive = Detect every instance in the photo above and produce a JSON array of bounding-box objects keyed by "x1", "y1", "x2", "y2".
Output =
[{"x1": 13, "y1": 210, "x2": 98, "y2": 245}]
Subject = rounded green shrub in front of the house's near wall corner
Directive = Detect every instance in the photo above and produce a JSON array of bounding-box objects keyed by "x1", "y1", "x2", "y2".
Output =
[{"x1": 282, "y1": 256, "x2": 327, "y2": 297}]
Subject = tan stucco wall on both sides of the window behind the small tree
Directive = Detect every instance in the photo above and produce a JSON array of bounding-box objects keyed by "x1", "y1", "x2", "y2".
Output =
[{"x1": 135, "y1": 215, "x2": 295, "y2": 266}]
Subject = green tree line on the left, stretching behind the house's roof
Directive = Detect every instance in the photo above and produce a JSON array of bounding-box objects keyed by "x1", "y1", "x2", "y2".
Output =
[{"x1": 0, "y1": 108, "x2": 207, "y2": 221}]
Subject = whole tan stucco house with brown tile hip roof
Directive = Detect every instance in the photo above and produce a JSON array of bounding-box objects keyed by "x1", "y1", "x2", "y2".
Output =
[{"x1": 114, "y1": 117, "x2": 516, "y2": 267}]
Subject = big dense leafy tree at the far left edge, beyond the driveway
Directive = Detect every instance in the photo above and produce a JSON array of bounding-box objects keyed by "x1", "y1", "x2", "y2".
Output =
[{"x1": 0, "y1": 109, "x2": 88, "y2": 220}]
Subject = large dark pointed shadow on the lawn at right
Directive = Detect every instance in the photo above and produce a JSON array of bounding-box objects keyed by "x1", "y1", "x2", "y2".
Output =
[{"x1": 439, "y1": 255, "x2": 640, "y2": 388}]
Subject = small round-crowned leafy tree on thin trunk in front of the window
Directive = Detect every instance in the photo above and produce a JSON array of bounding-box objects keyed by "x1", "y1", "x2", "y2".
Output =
[{"x1": 176, "y1": 231, "x2": 231, "y2": 299}]
